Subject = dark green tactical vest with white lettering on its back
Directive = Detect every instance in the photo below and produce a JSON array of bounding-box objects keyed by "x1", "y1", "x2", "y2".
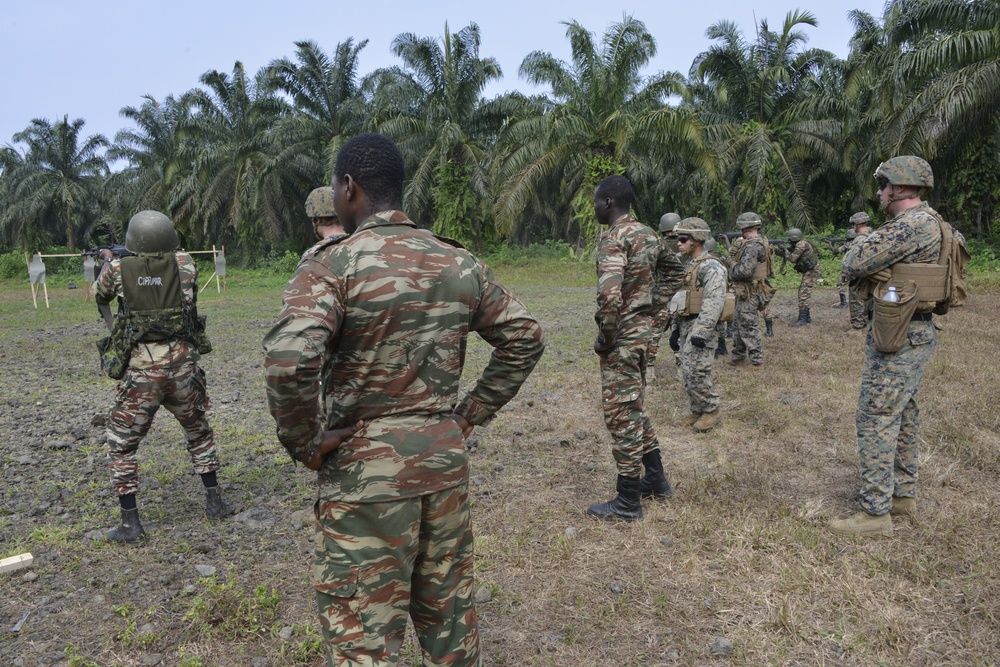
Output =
[{"x1": 120, "y1": 252, "x2": 188, "y2": 343}]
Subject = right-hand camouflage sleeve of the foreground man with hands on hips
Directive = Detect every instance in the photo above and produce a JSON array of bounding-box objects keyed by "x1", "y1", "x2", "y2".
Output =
[{"x1": 455, "y1": 265, "x2": 545, "y2": 426}]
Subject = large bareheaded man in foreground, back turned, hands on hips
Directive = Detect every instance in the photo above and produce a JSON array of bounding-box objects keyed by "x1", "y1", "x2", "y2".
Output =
[{"x1": 264, "y1": 134, "x2": 544, "y2": 667}]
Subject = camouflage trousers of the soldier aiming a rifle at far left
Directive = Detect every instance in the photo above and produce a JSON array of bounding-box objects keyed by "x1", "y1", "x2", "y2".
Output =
[{"x1": 107, "y1": 362, "x2": 219, "y2": 496}]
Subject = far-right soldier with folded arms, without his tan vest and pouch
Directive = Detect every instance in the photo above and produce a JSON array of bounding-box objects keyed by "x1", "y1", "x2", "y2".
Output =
[{"x1": 829, "y1": 155, "x2": 943, "y2": 535}]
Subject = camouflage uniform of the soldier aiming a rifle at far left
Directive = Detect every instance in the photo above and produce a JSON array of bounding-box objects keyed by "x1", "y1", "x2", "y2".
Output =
[{"x1": 91, "y1": 251, "x2": 219, "y2": 496}]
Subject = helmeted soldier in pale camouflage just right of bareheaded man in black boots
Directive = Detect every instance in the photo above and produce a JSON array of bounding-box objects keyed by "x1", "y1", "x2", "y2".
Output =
[{"x1": 670, "y1": 218, "x2": 728, "y2": 432}]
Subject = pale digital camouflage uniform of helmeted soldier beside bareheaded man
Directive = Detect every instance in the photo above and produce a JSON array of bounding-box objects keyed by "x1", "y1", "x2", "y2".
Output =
[{"x1": 671, "y1": 252, "x2": 728, "y2": 415}]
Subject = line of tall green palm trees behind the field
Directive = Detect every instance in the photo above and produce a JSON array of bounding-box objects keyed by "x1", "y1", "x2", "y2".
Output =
[{"x1": 0, "y1": 0, "x2": 1000, "y2": 263}]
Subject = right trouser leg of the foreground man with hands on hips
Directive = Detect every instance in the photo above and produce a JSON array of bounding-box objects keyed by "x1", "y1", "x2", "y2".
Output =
[{"x1": 410, "y1": 484, "x2": 480, "y2": 667}]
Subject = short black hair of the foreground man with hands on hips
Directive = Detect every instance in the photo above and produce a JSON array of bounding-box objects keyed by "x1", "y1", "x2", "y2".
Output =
[{"x1": 333, "y1": 132, "x2": 405, "y2": 208}]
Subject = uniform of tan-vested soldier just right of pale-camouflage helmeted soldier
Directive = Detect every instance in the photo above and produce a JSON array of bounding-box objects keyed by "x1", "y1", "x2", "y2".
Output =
[{"x1": 729, "y1": 235, "x2": 774, "y2": 366}]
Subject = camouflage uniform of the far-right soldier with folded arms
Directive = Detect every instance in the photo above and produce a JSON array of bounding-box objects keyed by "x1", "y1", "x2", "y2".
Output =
[{"x1": 843, "y1": 203, "x2": 941, "y2": 516}]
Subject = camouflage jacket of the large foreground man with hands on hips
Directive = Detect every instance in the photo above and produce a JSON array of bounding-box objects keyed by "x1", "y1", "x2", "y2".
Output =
[{"x1": 264, "y1": 211, "x2": 544, "y2": 502}]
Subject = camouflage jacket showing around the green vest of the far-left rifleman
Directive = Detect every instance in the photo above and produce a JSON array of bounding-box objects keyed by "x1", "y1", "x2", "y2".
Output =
[{"x1": 90, "y1": 250, "x2": 201, "y2": 370}]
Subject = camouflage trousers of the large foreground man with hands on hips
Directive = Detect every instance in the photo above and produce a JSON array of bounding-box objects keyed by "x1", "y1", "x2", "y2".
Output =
[{"x1": 311, "y1": 483, "x2": 480, "y2": 667}]
